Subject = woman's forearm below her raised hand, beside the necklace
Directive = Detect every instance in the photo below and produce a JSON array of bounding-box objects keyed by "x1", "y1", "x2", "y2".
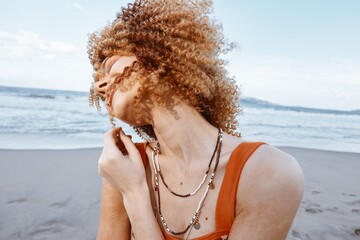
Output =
[{"x1": 123, "y1": 186, "x2": 164, "y2": 240}]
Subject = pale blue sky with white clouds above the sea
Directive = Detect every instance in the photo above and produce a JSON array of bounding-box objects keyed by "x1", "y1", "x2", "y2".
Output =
[{"x1": 0, "y1": 0, "x2": 360, "y2": 110}]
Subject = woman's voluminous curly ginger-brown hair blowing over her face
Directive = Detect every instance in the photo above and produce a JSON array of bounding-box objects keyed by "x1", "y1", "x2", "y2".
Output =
[{"x1": 88, "y1": 0, "x2": 241, "y2": 138}]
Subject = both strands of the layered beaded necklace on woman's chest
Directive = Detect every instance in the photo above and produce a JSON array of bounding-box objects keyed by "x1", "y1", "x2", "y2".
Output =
[{"x1": 152, "y1": 128, "x2": 222, "y2": 235}]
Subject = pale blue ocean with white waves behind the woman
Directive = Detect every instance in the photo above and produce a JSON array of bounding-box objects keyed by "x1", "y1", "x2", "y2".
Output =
[{"x1": 0, "y1": 86, "x2": 360, "y2": 152}]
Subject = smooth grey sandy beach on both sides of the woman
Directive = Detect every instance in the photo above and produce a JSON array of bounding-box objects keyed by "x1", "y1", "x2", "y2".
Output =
[{"x1": 0, "y1": 147, "x2": 360, "y2": 240}]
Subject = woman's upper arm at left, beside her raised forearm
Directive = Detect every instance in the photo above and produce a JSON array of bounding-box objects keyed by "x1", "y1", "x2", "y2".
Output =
[{"x1": 97, "y1": 178, "x2": 130, "y2": 240}]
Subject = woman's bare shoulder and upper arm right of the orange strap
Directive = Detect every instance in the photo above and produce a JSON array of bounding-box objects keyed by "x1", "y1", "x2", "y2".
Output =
[{"x1": 229, "y1": 145, "x2": 304, "y2": 240}]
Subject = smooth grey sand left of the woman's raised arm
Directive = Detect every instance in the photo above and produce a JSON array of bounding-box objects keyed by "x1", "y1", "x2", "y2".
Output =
[{"x1": 0, "y1": 149, "x2": 101, "y2": 240}]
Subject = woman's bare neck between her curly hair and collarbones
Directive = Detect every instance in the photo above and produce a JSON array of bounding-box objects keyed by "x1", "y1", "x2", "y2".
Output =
[{"x1": 152, "y1": 103, "x2": 218, "y2": 171}]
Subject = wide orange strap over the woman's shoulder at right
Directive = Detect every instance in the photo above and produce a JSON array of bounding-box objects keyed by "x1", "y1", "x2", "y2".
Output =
[{"x1": 216, "y1": 142, "x2": 265, "y2": 230}]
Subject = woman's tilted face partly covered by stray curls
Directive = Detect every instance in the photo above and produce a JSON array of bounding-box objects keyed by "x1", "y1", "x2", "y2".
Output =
[{"x1": 95, "y1": 55, "x2": 140, "y2": 125}]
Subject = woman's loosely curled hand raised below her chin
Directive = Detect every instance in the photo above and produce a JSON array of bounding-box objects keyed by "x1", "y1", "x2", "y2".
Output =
[{"x1": 98, "y1": 128, "x2": 146, "y2": 195}]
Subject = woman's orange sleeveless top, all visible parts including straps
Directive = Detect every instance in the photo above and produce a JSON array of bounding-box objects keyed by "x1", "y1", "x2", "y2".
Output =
[{"x1": 136, "y1": 142, "x2": 264, "y2": 240}]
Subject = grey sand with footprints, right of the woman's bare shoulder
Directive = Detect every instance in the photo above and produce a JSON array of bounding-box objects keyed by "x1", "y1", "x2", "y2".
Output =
[{"x1": 281, "y1": 147, "x2": 360, "y2": 240}]
